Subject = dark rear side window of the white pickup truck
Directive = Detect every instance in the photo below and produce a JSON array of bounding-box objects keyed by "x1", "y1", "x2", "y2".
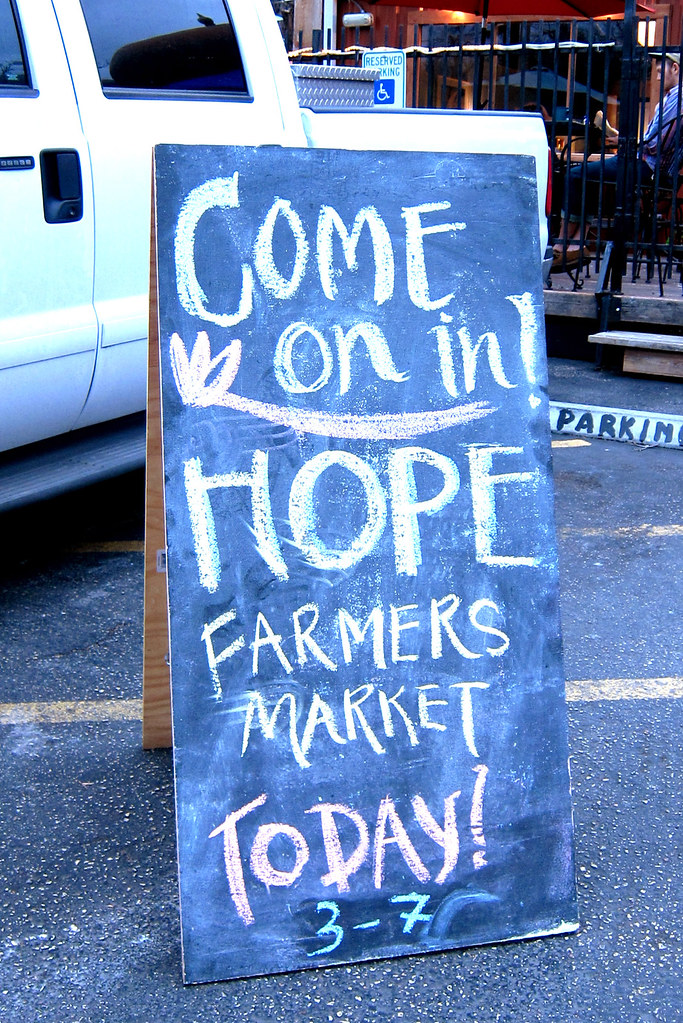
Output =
[{"x1": 81, "y1": 0, "x2": 247, "y2": 96}]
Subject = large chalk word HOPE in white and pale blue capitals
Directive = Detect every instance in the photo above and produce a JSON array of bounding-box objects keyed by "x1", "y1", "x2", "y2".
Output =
[{"x1": 184, "y1": 445, "x2": 542, "y2": 593}]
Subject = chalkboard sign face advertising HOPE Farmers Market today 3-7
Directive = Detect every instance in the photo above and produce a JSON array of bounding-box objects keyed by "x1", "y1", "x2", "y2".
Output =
[{"x1": 155, "y1": 146, "x2": 577, "y2": 982}]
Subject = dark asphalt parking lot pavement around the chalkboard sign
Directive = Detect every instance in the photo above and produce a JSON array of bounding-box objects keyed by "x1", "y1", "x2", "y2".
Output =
[{"x1": 0, "y1": 360, "x2": 683, "y2": 1023}]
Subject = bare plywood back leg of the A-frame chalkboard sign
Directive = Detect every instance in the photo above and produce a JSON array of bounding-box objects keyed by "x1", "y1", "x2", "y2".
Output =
[{"x1": 142, "y1": 181, "x2": 173, "y2": 750}]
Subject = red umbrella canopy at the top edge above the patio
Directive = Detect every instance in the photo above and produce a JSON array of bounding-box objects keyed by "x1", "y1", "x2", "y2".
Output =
[{"x1": 366, "y1": 0, "x2": 640, "y2": 21}]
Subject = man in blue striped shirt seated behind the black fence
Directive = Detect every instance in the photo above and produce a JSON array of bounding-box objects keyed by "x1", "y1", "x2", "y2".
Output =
[{"x1": 552, "y1": 53, "x2": 683, "y2": 270}]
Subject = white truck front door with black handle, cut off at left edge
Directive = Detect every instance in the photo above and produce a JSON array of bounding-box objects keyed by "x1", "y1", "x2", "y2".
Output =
[{"x1": 0, "y1": 0, "x2": 97, "y2": 450}]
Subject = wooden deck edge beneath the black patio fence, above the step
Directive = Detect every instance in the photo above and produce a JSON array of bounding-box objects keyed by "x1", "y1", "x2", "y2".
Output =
[{"x1": 544, "y1": 257, "x2": 683, "y2": 328}]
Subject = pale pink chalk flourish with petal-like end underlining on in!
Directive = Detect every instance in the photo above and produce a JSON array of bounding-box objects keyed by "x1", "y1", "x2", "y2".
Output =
[{"x1": 171, "y1": 330, "x2": 496, "y2": 440}]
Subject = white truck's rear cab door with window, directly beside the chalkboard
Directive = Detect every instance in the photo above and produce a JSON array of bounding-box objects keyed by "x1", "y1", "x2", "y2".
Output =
[{"x1": 53, "y1": 0, "x2": 306, "y2": 426}]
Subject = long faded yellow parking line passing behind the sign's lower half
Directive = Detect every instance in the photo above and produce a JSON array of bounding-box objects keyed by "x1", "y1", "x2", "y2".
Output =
[{"x1": 0, "y1": 675, "x2": 683, "y2": 725}]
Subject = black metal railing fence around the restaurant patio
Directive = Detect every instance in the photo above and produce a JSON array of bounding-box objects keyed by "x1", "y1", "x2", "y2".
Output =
[{"x1": 290, "y1": 20, "x2": 683, "y2": 294}]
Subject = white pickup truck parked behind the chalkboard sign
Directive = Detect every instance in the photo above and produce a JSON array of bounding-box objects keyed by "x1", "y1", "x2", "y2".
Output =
[{"x1": 0, "y1": 0, "x2": 548, "y2": 509}]
